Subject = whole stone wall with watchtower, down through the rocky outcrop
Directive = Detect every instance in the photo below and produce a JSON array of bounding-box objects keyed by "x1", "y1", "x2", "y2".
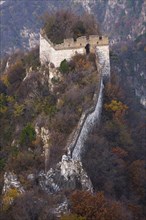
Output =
[{"x1": 39, "y1": 32, "x2": 110, "y2": 193}]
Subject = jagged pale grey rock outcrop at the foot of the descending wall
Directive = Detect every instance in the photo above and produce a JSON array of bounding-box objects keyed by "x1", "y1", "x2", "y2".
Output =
[{"x1": 38, "y1": 155, "x2": 93, "y2": 193}]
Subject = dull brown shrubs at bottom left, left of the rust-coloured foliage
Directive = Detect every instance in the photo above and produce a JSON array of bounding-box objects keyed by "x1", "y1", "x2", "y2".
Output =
[{"x1": 0, "y1": 191, "x2": 61, "y2": 220}]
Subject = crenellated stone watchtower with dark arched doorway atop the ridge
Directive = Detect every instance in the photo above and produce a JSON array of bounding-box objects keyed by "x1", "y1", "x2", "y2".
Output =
[{"x1": 40, "y1": 30, "x2": 109, "y2": 67}]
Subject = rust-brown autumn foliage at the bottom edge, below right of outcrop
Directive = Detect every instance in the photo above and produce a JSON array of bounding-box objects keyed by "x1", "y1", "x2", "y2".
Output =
[{"x1": 62, "y1": 191, "x2": 130, "y2": 220}]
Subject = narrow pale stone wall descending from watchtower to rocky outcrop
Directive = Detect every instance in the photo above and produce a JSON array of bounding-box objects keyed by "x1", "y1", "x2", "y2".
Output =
[{"x1": 69, "y1": 46, "x2": 110, "y2": 160}]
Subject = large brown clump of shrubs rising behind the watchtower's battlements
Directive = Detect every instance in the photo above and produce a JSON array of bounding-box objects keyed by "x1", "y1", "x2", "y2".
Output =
[{"x1": 42, "y1": 10, "x2": 100, "y2": 44}]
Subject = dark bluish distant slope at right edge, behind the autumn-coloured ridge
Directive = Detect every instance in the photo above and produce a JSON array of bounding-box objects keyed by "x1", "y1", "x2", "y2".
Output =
[{"x1": 111, "y1": 34, "x2": 146, "y2": 108}]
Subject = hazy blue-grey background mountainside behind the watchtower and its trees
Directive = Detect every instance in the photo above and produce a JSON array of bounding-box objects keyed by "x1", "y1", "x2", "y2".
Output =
[{"x1": 0, "y1": 0, "x2": 146, "y2": 54}]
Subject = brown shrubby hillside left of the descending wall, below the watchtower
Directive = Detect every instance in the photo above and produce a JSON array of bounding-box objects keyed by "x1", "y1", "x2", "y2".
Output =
[{"x1": 0, "y1": 49, "x2": 99, "y2": 220}]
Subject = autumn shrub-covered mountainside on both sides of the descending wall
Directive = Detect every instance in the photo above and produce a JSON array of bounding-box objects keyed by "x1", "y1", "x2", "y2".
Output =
[{"x1": 0, "y1": 43, "x2": 146, "y2": 220}]
